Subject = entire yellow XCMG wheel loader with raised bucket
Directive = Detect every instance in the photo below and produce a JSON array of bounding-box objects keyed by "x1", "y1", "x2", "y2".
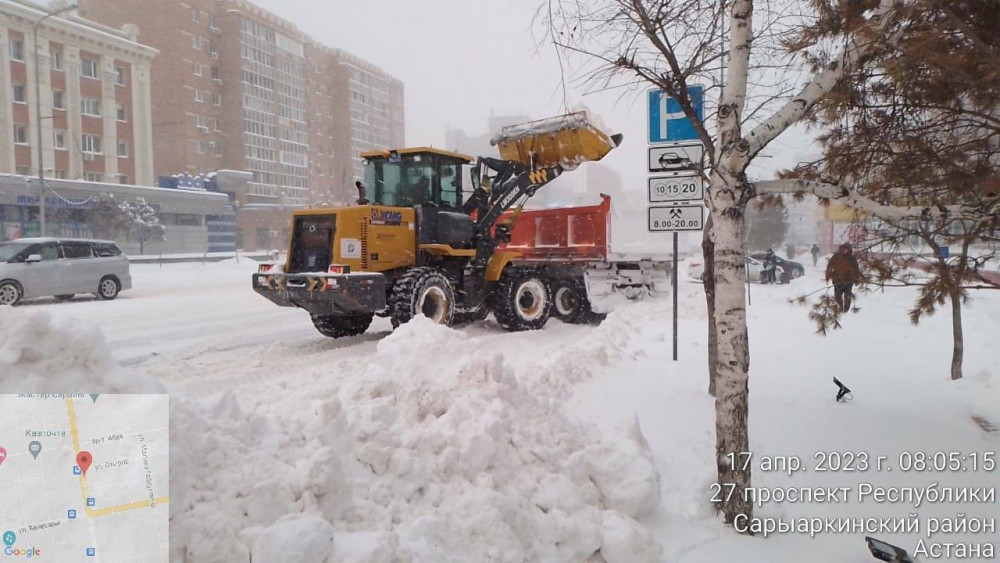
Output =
[{"x1": 253, "y1": 112, "x2": 621, "y2": 338}]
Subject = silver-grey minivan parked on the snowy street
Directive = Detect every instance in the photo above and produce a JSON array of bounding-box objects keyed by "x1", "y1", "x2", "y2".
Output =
[{"x1": 0, "y1": 238, "x2": 132, "y2": 305}]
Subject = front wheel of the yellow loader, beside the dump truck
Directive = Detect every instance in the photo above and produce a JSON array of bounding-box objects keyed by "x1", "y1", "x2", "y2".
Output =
[{"x1": 491, "y1": 271, "x2": 552, "y2": 331}]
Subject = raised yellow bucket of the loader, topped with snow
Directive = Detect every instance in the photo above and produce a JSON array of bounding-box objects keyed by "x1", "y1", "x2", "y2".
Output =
[{"x1": 490, "y1": 111, "x2": 622, "y2": 170}]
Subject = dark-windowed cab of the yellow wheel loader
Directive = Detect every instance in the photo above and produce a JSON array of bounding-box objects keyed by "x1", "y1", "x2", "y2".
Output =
[{"x1": 361, "y1": 147, "x2": 472, "y2": 210}]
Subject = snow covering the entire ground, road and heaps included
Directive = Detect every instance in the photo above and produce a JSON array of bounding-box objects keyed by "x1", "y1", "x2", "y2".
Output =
[{"x1": 0, "y1": 260, "x2": 1000, "y2": 563}]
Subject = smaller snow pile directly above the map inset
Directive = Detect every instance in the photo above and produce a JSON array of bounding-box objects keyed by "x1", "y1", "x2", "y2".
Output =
[{"x1": 0, "y1": 307, "x2": 165, "y2": 393}]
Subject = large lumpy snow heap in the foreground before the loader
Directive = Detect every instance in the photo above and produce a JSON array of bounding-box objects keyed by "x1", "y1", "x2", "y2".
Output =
[{"x1": 171, "y1": 318, "x2": 661, "y2": 562}]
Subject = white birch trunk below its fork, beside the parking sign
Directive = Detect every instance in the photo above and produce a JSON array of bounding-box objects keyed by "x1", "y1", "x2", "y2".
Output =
[{"x1": 711, "y1": 181, "x2": 753, "y2": 524}]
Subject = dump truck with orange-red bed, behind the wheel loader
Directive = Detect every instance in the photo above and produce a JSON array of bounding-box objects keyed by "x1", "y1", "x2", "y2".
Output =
[{"x1": 499, "y1": 194, "x2": 671, "y2": 322}]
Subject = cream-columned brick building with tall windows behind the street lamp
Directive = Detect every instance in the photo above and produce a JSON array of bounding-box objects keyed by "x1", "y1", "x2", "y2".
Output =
[{"x1": 0, "y1": 0, "x2": 157, "y2": 185}]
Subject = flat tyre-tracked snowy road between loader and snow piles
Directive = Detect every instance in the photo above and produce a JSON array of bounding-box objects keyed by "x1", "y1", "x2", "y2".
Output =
[{"x1": 24, "y1": 260, "x2": 612, "y2": 395}]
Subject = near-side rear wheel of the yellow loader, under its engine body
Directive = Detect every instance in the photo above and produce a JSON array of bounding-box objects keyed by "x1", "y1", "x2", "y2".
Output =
[{"x1": 389, "y1": 267, "x2": 455, "y2": 328}]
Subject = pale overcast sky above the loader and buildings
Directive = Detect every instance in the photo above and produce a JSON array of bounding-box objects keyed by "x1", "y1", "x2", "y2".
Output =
[{"x1": 255, "y1": 0, "x2": 808, "y2": 190}]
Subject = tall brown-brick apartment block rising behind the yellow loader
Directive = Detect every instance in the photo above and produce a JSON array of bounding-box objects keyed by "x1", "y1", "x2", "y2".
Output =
[{"x1": 80, "y1": 0, "x2": 404, "y2": 207}]
